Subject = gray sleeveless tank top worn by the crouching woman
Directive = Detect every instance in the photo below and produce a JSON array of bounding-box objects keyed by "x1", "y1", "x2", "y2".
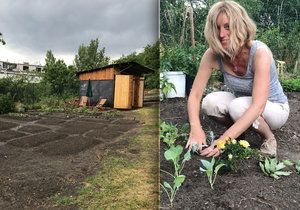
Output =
[{"x1": 218, "y1": 40, "x2": 288, "y2": 103}]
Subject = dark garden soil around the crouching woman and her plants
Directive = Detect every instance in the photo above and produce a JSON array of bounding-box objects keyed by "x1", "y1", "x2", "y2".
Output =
[{"x1": 160, "y1": 93, "x2": 300, "y2": 210}]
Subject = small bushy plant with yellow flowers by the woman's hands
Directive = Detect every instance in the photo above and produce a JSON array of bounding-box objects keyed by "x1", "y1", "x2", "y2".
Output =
[{"x1": 216, "y1": 138, "x2": 255, "y2": 171}]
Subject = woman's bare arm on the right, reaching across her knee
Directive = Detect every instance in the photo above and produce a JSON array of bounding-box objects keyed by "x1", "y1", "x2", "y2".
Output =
[{"x1": 201, "y1": 48, "x2": 272, "y2": 157}]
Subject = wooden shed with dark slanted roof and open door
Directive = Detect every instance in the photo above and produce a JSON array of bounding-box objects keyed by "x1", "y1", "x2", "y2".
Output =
[{"x1": 77, "y1": 62, "x2": 154, "y2": 109}]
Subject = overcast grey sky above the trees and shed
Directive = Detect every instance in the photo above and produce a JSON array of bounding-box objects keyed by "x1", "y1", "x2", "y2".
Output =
[{"x1": 0, "y1": 0, "x2": 158, "y2": 64}]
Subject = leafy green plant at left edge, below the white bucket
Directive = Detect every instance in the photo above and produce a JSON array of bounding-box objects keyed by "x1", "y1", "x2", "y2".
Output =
[{"x1": 159, "y1": 122, "x2": 179, "y2": 148}]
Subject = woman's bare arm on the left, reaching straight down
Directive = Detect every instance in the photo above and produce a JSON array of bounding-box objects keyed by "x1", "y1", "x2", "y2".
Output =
[{"x1": 186, "y1": 49, "x2": 218, "y2": 148}]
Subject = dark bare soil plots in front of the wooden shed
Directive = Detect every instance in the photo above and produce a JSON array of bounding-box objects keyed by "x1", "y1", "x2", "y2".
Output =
[{"x1": 0, "y1": 111, "x2": 142, "y2": 209}]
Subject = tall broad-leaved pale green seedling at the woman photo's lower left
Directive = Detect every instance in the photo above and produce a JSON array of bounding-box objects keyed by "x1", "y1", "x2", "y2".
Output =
[{"x1": 160, "y1": 145, "x2": 191, "y2": 206}]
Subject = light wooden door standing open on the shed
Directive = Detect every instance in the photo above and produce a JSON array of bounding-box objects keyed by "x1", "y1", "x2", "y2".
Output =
[{"x1": 114, "y1": 75, "x2": 133, "y2": 109}]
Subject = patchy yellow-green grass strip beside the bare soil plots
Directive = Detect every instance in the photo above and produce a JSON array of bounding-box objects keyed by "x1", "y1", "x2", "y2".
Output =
[{"x1": 53, "y1": 106, "x2": 159, "y2": 209}]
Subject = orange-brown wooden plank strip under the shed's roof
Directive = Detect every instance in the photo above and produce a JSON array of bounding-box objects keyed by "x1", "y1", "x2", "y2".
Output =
[{"x1": 79, "y1": 68, "x2": 118, "y2": 80}]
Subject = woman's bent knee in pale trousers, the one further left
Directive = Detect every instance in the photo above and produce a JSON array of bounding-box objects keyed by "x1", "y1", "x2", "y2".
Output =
[{"x1": 202, "y1": 91, "x2": 235, "y2": 118}]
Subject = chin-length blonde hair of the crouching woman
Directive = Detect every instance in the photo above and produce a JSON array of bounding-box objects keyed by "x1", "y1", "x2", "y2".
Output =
[{"x1": 204, "y1": 1, "x2": 256, "y2": 60}]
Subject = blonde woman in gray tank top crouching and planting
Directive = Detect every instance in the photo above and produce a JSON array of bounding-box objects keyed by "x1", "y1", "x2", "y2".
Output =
[{"x1": 186, "y1": 1, "x2": 289, "y2": 157}]
